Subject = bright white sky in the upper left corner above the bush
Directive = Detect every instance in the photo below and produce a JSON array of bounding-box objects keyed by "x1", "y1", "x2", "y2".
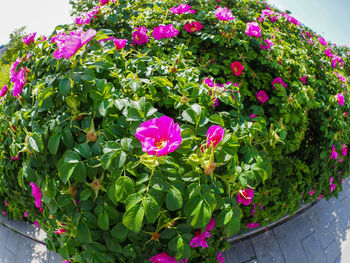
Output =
[{"x1": 0, "y1": 0, "x2": 73, "y2": 45}]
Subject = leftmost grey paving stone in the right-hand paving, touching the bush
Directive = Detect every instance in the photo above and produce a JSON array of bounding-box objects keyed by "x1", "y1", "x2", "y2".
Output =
[{"x1": 225, "y1": 239, "x2": 256, "y2": 263}]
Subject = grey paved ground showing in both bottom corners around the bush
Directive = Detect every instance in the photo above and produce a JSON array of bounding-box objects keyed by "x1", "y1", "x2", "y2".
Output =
[{"x1": 0, "y1": 178, "x2": 350, "y2": 263}]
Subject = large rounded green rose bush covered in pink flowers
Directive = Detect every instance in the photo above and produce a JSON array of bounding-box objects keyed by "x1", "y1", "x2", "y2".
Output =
[{"x1": 0, "y1": 0, "x2": 350, "y2": 262}]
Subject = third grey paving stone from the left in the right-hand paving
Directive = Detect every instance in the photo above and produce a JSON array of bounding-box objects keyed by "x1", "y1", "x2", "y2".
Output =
[{"x1": 273, "y1": 221, "x2": 308, "y2": 263}]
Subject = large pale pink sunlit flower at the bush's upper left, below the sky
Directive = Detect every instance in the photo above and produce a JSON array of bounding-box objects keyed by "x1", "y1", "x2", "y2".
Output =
[{"x1": 51, "y1": 28, "x2": 96, "y2": 59}]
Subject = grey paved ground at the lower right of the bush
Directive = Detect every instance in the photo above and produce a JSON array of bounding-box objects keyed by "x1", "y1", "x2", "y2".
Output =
[{"x1": 225, "y1": 178, "x2": 350, "y2": 263}]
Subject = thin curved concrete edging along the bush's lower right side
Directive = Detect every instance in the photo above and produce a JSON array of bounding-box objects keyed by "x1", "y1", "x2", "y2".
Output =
[{"x1": 227, "y1": 200, "x2": 318, "y2": 245}]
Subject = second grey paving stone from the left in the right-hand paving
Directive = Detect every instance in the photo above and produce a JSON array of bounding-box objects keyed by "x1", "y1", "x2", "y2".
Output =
[{"x1": 252, "y1": 231, "x2": 285, "y2": 263}]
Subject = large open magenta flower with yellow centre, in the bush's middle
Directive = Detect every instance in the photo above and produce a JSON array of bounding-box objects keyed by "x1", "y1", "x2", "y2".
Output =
[{"x1": 135, "y1": 116, "x2": 182, "y2": 156}]
